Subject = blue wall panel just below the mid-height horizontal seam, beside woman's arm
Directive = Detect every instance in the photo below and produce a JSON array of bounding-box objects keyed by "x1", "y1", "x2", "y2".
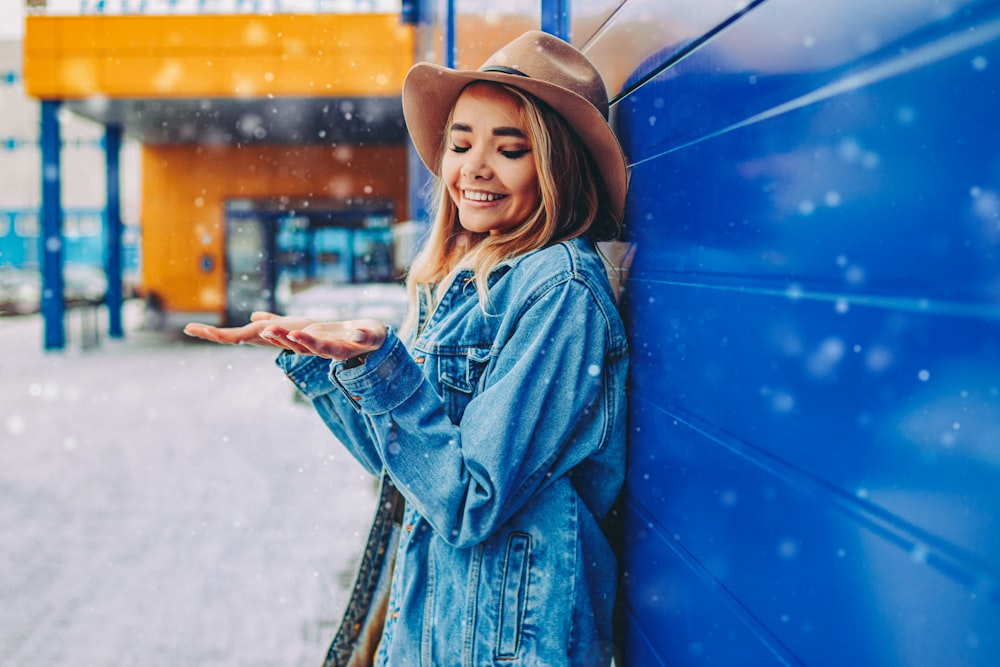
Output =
[{"x1": 632, "y1": 283, "x2": 1000, "y2": 569}]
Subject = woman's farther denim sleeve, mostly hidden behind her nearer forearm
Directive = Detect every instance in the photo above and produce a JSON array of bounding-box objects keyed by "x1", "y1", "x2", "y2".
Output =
[{"x1": 276, "y1": 352, "x2": 382, "y2": 475}]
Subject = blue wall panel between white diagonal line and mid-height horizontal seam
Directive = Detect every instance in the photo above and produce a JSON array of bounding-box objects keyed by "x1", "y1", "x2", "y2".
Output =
[{"x1": 629, "y1": 28, "x2": 1000, "y2": 300}]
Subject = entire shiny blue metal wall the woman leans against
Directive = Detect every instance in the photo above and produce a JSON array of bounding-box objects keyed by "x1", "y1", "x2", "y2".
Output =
[{"x1": 620, "y1": 0, "x2": 1000, "y2": 667}]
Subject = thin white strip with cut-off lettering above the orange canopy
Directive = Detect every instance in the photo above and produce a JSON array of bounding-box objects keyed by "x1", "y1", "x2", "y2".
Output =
[{"x1": 24, "y1": 0, "x2": 401, "y2": 16}]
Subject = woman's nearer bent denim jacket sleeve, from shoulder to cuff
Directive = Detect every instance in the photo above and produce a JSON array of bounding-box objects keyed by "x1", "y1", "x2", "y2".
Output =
[{"x1": 334, "y1": 279, "x2": 627, "y2": 547}]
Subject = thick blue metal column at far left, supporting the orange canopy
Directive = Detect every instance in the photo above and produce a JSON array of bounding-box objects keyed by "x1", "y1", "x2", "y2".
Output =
[{"x1": 39, "y1": 100, "x2": 66, "y2": 350}]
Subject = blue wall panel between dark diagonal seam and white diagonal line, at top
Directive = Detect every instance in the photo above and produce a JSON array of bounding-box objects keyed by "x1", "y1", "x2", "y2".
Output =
[{"x1": 620, "y1": 0, "x2": 997, "y2": 162}]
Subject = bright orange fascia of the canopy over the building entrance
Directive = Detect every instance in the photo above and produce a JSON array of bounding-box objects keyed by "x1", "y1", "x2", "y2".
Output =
[{"x1": 24, "y1": 12, "x2": 413, "y2": 99}]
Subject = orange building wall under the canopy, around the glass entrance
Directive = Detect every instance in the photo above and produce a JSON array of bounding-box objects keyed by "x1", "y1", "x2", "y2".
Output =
[{"x1": 141, "y1": 145, "x2": 406, "y2": 313}]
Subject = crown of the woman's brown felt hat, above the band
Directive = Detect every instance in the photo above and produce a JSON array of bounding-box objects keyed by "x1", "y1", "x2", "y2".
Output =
[{"x1": 480, "y1": 31, "x2": 608, "y2": 119}]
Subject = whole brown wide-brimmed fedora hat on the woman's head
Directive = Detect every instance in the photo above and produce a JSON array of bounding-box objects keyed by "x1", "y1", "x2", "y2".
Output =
[{"x1": 403, "y1": 31, "x2": 628, "y2": 220}]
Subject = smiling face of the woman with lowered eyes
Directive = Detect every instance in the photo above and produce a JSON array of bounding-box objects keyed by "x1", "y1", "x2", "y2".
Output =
[{"x1": 441, "y1": 84, "x2": 541, "y2": 233}]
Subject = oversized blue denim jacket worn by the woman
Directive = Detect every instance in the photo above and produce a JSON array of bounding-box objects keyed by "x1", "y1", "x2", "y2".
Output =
[{"x1": 278, "y1": 239, "x2": 628, "y2": 667}]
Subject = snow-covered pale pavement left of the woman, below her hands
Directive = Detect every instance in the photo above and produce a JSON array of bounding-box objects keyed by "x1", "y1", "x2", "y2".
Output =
[{"x1": 0, "y1": 310, "x2": 374, "y2": 667}]
